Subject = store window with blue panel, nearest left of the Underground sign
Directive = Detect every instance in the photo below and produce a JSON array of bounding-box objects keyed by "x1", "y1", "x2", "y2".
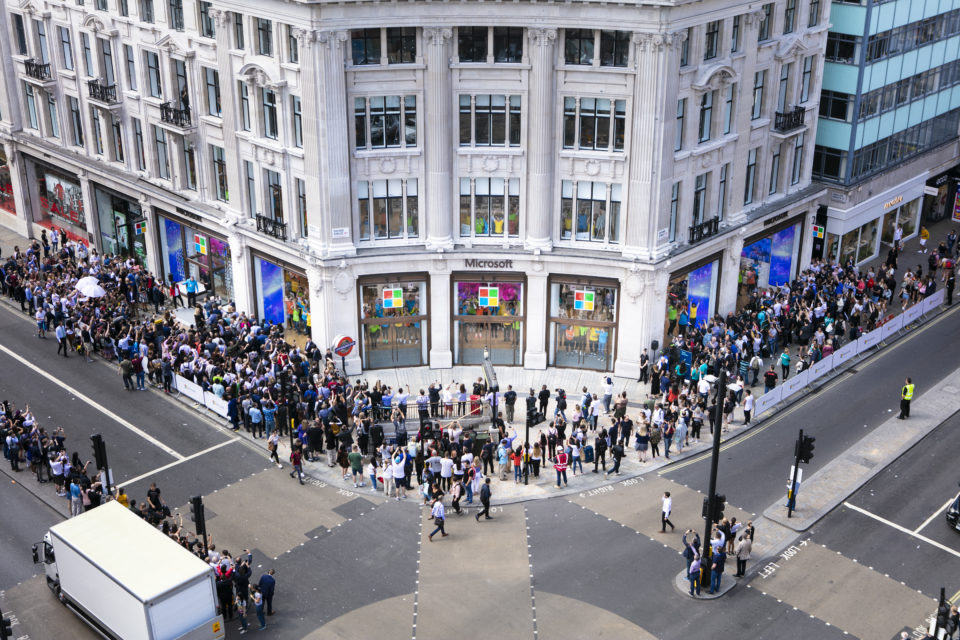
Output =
[{"x1": 253, "y1": 257, "x2": 311, "y2": 346}]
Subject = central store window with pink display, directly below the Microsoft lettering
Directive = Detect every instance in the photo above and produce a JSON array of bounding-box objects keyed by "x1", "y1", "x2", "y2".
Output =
[{"x1": 453, "y1": 276, "x2": 524, "y2": 365}]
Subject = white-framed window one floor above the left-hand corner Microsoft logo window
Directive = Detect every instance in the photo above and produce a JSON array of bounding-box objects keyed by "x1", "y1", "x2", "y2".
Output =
[{"x1": 357, "y1": 178, "x2": 419, "y2": 241}]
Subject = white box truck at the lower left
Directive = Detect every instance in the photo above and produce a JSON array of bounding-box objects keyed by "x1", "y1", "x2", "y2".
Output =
[{"x1": 33, "y1": 502, "x2": 224, "y2": 640}]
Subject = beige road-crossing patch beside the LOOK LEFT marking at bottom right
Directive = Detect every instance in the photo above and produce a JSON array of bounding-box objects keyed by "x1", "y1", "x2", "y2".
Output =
[{"x1": 750, "y1": 540, "x2": 936, "y2": 639}]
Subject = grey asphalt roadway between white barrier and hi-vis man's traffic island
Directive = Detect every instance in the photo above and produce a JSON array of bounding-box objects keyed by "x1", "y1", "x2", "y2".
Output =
[{"x1": 661, "y1": 310, "x2": 960, "y2": 513}]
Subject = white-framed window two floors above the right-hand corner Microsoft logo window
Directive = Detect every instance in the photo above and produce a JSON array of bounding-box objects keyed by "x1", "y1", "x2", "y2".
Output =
[{"x1": 563, "y1": 96, "x2": 627, "y2": 151}]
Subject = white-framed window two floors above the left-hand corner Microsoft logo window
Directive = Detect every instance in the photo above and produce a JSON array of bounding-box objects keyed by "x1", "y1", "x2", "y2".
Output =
[{"x1": 353, "y1": 96, "x2": 417, "y2": 149}]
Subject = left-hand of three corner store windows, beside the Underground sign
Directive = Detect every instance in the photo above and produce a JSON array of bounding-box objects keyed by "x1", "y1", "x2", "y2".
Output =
[{"x1": 359, "y1": 276, "x2": 428, "y2": 369}]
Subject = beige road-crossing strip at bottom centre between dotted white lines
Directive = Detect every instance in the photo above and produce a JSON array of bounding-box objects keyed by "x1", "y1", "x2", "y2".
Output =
[{"x1": 416, "y1": 505, "x2": 533, "y2": 640}]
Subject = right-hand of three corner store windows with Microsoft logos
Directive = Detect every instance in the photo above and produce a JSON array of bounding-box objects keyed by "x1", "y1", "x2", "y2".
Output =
[{"x1": 550, "y1": 280, "x2": 619, "y2": 371}]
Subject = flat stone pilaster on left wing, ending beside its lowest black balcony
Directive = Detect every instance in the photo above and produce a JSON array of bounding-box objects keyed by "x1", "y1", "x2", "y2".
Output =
[{"x1": 210, "y1": 9, "x2": 244, "y2": 217}]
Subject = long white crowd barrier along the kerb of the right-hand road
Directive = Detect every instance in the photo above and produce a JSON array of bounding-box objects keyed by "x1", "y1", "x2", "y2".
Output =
[{"x1": 753, "y1": 296, "x2": 944, "y2": 416}]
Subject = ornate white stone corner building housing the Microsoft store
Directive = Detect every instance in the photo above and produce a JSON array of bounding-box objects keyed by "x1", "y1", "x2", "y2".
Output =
[{"x1": 0, "y1": 0, "x2": 830, "y2": 376}]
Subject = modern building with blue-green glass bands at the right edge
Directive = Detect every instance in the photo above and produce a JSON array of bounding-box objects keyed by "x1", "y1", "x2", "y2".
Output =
[{"x1": 813, "y1": 0, "x2": 960, "y2": 264}]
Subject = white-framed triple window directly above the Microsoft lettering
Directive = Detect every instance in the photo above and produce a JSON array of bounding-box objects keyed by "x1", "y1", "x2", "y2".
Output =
[{"x1": 460, "y1": 178, "x2": 520, "y2": 238}]
